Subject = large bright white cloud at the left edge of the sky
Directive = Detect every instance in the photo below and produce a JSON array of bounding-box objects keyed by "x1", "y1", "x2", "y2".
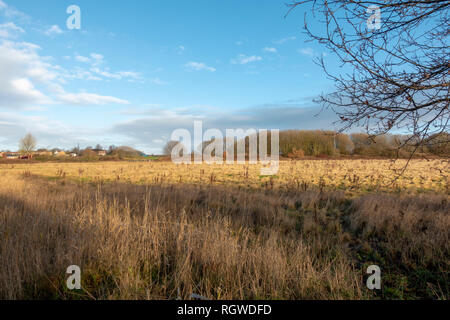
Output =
[{"x1": 0, "y1": 41, "x2": 133, "y2": 110}]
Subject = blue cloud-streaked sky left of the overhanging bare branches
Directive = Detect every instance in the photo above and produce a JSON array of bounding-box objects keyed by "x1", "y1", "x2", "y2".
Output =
[{"x1": 0, "y1": 0, "x2": 335, "y2": 153}]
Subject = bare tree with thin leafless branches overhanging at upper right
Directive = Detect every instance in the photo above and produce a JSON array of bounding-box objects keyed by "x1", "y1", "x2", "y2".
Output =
[{"x1": 289, "y1": 0, "x2": 450, "y2": 153}]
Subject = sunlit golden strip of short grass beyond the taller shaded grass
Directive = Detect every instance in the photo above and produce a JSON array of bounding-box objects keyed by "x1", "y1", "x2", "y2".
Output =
[{"x1": 0, "y1": 159, "x2": 450, "y2": 194}]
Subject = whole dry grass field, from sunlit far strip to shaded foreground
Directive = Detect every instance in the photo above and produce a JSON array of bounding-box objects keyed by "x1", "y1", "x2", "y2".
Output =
[{"x1": 0, "y1": 160, "x2": 450, "y2": 299}]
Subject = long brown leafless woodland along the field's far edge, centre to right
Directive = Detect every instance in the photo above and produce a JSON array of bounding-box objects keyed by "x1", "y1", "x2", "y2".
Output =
[{"x1": 164, "y1": 130, "x2": 450, "y2": 159}]
